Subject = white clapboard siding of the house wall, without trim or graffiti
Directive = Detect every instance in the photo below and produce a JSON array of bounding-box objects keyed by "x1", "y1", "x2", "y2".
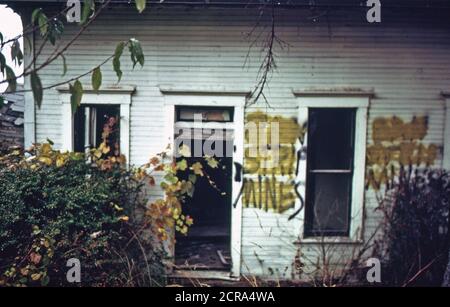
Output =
[{"x1": 24, "y1": 7, "x2": 450, "y2": 278}]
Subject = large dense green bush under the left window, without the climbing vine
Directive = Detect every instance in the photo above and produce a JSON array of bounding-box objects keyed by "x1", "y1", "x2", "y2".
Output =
[{"x1": 0, "y1": 144, "x2": 164, "y2": 286}]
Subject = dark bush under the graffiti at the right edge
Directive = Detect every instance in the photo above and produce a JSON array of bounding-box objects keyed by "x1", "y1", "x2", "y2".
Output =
[{"x1": 378, "y1": 169, "x2": 450, "y2": 286}]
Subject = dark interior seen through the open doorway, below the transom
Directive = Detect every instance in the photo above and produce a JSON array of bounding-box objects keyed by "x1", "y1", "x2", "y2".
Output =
[{"x1": 175, "y1": 140, "x2": 232, "y2": 270}]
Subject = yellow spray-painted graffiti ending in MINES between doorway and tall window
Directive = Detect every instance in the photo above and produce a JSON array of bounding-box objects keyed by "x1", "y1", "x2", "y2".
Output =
[{"x1": 242, "y1": 111, "x2": 306, "y2": 213}]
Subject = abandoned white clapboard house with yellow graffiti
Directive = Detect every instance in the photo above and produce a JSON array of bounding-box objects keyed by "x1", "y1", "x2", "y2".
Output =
[{"x1": 6, "y1": 0, "x2": 450, "y2": 278}]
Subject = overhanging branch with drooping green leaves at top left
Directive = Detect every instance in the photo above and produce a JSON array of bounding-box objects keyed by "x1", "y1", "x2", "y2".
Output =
[{"x1": 0, "y1": 0, "x2": 147, "y2": 112}]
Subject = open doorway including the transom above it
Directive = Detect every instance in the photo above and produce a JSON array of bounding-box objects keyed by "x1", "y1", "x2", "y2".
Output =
[{"x1": 175, "y1": 108, "x2": 233, "y2": 271}]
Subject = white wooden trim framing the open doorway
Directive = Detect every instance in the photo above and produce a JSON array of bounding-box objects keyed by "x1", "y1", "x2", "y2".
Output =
[{"x1": 160, "y1": 88, "x2": 249, "y2": 277}]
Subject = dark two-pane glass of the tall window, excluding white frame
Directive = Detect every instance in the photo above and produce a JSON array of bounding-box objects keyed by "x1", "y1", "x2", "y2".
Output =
[{"x1": 305, "y1": 108, "x2": 356, "y2": 236}]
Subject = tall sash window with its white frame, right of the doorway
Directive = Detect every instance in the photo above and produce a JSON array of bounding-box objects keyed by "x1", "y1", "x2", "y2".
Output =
[{"x1": 294, "y1": 89, "x2": 374, "y2": 244}]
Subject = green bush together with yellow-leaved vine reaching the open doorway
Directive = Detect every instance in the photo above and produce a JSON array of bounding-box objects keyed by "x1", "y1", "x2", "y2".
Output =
[{"x1": 0, "y1": 119, "x2": 217, "y2": 286}]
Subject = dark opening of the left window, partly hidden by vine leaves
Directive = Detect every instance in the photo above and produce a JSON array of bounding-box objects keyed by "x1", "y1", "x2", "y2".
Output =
[{"x1": 73, "y1": 105, "x2": 120, "y2": 155}]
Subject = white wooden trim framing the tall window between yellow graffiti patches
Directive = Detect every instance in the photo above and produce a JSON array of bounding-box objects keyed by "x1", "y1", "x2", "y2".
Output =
[{"x1": 294, "y1": 91, "x2": 373, "y2": 243}]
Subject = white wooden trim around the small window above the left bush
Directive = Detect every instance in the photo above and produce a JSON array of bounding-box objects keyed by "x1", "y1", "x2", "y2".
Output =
[{"x1": 57, "y1": 86, "x2": 136, "y2": 163}]
